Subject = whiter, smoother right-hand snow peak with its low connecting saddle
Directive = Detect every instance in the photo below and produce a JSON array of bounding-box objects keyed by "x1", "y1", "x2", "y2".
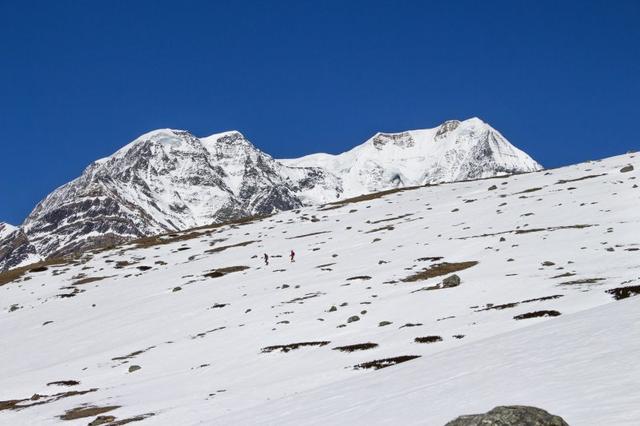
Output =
[{"x1": 280, "y1": 118, "x2": 542, "y2": 196}]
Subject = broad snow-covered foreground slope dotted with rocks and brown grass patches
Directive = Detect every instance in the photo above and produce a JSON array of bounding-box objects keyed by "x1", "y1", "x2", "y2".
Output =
[{"x1": 0, "y1": 154, "x2": 640, "y2": 425}]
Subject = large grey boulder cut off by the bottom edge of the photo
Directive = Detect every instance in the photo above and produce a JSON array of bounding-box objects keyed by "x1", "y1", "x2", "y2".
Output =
[{"x1": 445, "y1": 405, "x2": 569, "y2": 426}]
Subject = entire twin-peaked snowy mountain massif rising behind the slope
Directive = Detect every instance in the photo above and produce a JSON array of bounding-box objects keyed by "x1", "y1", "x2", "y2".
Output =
[{"x1": 0, "y1": 118, "x2": 541, "y2": 270}]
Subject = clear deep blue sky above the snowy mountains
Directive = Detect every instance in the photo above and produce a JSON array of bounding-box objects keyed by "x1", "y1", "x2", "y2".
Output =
[{"x1": 0, "y1": 0, "x2": 640, "y2": 224}]
